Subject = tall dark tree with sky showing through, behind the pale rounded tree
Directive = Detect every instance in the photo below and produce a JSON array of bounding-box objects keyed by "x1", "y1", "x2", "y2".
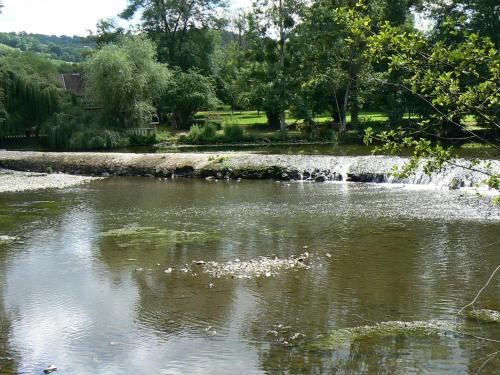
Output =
[{"x1": 120, "y1": 0, "x2": 224, "y2": 72}]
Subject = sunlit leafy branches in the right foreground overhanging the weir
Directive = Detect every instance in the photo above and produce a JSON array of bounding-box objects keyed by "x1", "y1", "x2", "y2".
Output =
[{"x1": 340, "y1": 3, "x2": 500, "y2": 189}]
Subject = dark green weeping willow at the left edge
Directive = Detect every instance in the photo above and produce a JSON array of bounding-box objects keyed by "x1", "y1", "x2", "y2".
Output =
[{"x1": 0, "y1": 69, "x2": 60, "y2": 135}]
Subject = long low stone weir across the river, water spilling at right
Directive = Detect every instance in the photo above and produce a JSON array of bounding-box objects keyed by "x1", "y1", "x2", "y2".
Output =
[{"x1": 0, "y1": 151, "x2": 500, "y2": 188}]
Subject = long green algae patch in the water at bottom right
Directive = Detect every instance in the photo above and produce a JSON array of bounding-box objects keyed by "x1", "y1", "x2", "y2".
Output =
[{"x1": 309, "y1": 320, "x2": 454, "y2": 350}]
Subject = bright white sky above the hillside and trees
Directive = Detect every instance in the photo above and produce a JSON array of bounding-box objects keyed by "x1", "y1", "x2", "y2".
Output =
[{"x1": 0, "y1": 0, "x2": 251, "y2": 36}]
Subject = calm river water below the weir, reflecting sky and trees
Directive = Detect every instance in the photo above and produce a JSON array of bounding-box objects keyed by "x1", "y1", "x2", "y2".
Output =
[{"x1": 0, "y1": 178, "x2": 500, "y2": 374}]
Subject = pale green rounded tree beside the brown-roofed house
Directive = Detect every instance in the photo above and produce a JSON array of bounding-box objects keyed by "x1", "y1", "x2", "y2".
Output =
[{"x1": 84, "y1": 36, "x2": 171, "y2": 128}]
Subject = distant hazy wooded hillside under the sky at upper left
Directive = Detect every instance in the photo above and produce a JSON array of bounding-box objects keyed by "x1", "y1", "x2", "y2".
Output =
[{"x1": 0, "y1": 32, "x2": 95, "y2": 62}]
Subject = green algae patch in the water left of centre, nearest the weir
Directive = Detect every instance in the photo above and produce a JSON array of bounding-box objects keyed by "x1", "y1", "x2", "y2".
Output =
[{"x1": 101, "y1": 227, "x2": 218, "y2": 247}]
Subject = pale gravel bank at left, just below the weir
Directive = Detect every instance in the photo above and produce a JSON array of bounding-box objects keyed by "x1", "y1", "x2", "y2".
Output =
[{"x1": 0, "y1": 168, "x2": 98, "y2": 193}]
